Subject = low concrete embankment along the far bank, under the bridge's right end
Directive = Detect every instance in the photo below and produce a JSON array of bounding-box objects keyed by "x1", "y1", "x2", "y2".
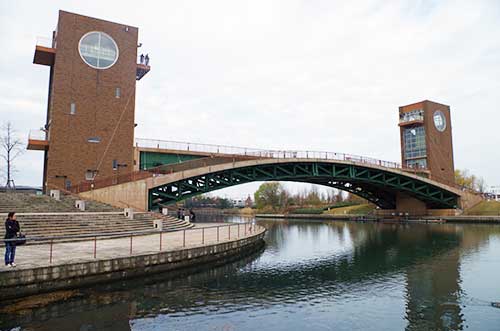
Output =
[{"x1": 255, "y1": 214, "x2": 500, "y2": 224}]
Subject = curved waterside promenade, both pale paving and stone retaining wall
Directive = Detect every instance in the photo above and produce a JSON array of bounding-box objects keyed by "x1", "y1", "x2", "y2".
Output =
[{"x1": 0, "y1": 223, "x2": 266, "y2": 299}]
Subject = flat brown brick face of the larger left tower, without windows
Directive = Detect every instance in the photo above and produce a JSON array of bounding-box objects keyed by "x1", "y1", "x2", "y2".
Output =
[{"x1": 45, "y1": 11, "x2": 138, "y2": 191}]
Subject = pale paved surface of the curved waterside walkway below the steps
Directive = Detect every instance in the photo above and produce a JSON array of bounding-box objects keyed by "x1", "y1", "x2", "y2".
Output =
[{"x1": 0, "y1": 223, "x2": 263, "y2": 272}]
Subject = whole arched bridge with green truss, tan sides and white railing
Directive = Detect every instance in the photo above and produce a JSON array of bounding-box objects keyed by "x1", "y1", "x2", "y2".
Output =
[{"x1": 71, "y1": 141, "x2": 481, "y2": 215}]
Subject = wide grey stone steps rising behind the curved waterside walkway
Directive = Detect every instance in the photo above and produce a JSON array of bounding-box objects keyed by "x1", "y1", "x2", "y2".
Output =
[{"x1": 0, "y1": 192, "x2": 193, "y2": 245}]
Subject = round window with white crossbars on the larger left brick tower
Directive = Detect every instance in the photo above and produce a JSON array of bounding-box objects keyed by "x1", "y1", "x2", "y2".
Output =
[{"x1": 78, "y1": 31, "x2": 118, "y2": 69}]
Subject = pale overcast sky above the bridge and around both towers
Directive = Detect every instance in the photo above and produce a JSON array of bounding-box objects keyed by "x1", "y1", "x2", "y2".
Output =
[{"x1": 0, "y1": 0, "x2": 500, "y2": 197}]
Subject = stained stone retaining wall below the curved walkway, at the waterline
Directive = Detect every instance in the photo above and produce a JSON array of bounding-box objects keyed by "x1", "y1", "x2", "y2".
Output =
[{"x1": 0, "y1": 227, "x2": 266, "y2": 300}]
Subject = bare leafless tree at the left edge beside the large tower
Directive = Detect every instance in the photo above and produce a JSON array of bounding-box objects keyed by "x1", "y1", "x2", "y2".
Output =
[{"x1": 0, "y1": 122, "x2": 23, "y2": 189}]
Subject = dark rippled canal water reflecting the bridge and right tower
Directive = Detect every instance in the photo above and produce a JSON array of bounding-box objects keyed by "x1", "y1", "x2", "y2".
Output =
[{"x1": 0, "y1": 216, "x2": 500, "y2": 331}]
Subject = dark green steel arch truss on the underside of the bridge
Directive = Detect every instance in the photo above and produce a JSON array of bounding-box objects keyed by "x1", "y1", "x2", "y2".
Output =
[{"x1": 149, "y1": 162, "x2": 458, "y2": 209}]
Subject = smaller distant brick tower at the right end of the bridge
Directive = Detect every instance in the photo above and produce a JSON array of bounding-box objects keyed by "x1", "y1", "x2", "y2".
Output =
[{"x1": 399, "y1": 100, "x2": 455, "y2": 184}]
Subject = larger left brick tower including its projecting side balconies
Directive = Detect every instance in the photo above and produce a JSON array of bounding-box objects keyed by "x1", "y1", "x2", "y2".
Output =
[{"x1": 28, "y1": 11, "x2": 150, "y2": 190}]
